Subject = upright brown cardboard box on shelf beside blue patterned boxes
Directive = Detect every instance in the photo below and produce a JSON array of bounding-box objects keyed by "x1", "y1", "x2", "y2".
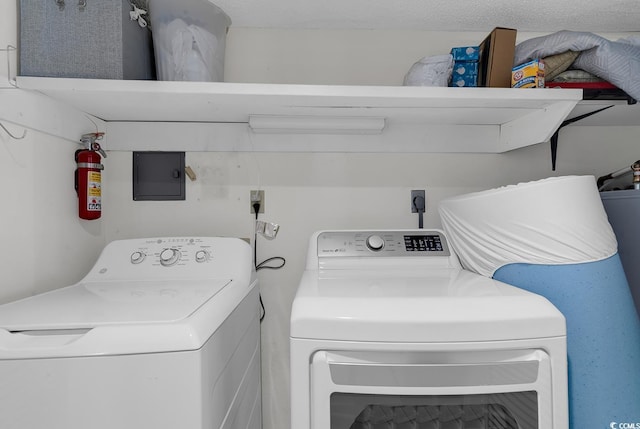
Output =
[{"x1": 478, "y1": 27, "x2": 517, "y2": 88}]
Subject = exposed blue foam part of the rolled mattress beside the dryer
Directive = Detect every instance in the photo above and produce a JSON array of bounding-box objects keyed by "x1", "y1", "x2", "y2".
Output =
[{"x1": 494, "y1": 253, "x2": 640, "y2": 429}]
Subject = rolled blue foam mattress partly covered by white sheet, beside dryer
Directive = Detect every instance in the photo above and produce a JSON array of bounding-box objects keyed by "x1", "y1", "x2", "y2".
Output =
[{"x1": 439, "y1": 176, "x2": 640, "y2": 429}]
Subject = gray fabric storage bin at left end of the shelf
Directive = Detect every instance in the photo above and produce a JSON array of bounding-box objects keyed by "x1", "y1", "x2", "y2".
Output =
[{"x1": 19, "y1": 0, "x2": 155, "y2": 79}]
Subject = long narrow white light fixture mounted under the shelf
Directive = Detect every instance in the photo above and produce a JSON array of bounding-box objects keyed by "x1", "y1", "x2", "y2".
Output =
[{"x1": 249, "y1": 115, "x2": 385, "y2": 135}]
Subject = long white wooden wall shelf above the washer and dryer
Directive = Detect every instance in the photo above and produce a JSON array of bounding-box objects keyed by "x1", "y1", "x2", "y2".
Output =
[{"x1": 17, "y1": 77, "x2": 582, "y2": 153}]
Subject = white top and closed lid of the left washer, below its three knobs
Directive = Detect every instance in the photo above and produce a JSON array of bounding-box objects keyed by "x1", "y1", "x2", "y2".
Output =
[{"x1": 0, "y1": 279, "x2": 244, "y2": 359}]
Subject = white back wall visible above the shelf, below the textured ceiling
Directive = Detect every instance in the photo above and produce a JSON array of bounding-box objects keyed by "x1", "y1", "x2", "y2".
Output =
[{"x1": 225, "y1": 27, "x2": 637, "y2": 85}]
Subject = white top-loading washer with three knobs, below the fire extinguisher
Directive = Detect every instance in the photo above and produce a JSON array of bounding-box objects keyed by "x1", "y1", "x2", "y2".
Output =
[{"x1": 0, "y1": 237, "x2": 261, "y2": 429}]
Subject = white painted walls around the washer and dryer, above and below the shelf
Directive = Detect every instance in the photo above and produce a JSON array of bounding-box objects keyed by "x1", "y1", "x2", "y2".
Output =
[{"x1": 0, "y1": 2, "x2": 640, "y2": 429}]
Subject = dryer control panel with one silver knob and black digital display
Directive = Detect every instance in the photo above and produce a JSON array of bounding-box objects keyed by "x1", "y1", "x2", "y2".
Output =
[{"x1": 317, "y1": 229, "x2": 450, "y2": 258}]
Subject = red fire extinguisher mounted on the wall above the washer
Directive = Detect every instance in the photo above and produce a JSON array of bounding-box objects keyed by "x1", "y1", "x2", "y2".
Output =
[{"x1": 75, "y1": 133, "x2": 107, "y2": 220}]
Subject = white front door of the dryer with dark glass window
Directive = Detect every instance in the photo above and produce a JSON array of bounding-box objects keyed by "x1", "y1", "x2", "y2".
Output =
[{"x1": 311, "y1": 349, "x2": 555, "y2": 429}]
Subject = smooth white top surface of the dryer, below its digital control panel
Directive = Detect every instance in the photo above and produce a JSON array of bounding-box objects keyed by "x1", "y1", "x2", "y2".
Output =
[{"x1": 291, "y1": 268, "x2": 566, "y2": 342}]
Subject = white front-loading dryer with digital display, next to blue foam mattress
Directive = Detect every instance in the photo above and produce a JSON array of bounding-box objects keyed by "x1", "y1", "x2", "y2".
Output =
[{"x1": 290, "y1": 229, "x2": 568, "y2": 429}]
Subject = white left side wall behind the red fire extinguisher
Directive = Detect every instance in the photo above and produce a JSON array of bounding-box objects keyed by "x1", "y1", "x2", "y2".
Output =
[{"x1": 0, "y1": 1, "x2": 104, "y2": 303}]
